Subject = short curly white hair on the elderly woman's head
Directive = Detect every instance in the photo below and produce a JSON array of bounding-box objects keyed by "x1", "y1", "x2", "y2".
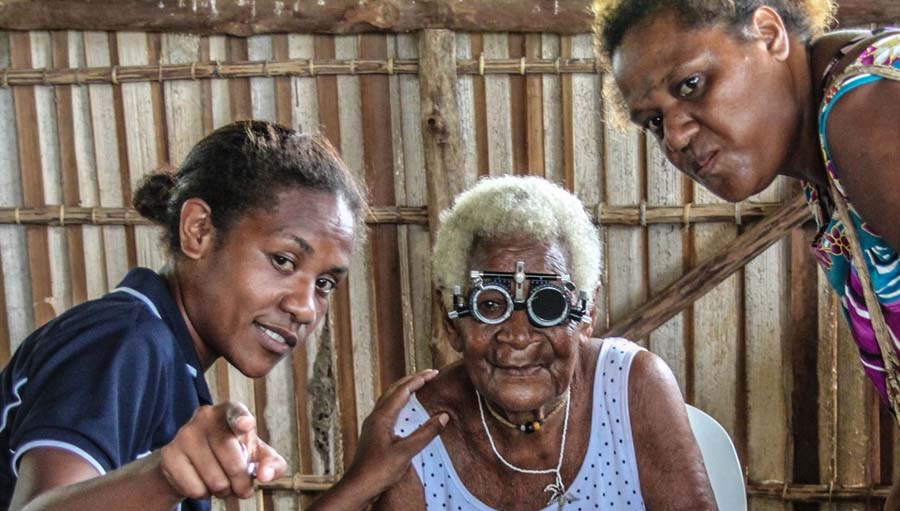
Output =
[{"x1": 432, "y1": 176, "x2": 602, "y2": 310}]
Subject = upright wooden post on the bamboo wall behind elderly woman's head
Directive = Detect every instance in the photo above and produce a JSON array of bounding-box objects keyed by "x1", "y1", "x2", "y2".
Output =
[{"x1": 419, "y1": 29, "x2": 465, "y2": 367}]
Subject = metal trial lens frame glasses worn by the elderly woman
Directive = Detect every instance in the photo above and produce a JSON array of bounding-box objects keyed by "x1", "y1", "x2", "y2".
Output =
[{"x1": 447, "y1": 261, "x2": 591, "y2": 328}]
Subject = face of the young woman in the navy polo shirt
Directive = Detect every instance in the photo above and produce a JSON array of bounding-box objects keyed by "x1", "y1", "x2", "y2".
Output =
[{"x1": 188, "y1": 188, "x2": 354, "y2": 378}]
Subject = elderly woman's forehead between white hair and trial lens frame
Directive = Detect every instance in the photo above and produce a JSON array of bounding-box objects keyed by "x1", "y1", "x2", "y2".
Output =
[{"x1": 469, "y1": 238, "x2": 569, "y2": 274}]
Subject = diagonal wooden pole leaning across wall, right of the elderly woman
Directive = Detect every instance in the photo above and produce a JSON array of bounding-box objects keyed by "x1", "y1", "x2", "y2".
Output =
[{"x1": 600, "y1": 194, "x2": 810, "y2": 339}]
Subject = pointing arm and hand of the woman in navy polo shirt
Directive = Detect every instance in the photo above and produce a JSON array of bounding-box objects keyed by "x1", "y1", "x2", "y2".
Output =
[{"x1": 10, "y1": 403, "x2": 287, "y2": 511}]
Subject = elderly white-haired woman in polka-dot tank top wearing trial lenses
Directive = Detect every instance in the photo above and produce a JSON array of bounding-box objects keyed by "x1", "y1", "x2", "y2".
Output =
[{"x1": 376, "y1": 176, "x2": 716, "y2": 511}]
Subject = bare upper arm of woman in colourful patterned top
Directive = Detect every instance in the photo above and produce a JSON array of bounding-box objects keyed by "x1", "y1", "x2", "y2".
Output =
[{"x1": 826, "y1": 75, "x2": 900, "y2": 252}]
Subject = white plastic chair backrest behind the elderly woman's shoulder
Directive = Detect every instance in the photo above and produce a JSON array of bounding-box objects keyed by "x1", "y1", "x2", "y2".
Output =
[{"x1": 686, "y1": 405, "x2": 747, "y2": 511}]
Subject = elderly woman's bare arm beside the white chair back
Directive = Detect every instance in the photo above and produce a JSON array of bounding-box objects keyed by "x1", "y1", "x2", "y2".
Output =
[{"x1": 628, "y1": 351, "x2": 717, "y2": 511}]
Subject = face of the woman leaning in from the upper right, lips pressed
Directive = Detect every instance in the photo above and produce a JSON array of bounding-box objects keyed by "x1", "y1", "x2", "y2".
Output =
[{"x1": 613, "y1": 12, "x2": 800, "y2": 201}]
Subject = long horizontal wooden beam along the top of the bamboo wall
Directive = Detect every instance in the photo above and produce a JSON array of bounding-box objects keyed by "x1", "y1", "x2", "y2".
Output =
[{"x1": 0, "y1": 0, "x2": 900, "y2": 36}]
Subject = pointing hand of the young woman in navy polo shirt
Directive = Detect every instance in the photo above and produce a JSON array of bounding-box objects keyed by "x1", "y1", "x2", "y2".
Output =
[{"x1": 159, "y1": 402, "x2": 288, "y2": 499}]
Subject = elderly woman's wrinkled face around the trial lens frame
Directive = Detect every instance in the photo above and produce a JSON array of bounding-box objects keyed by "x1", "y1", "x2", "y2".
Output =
[{"x1": 456, "y1": 239, "x2": 586, "y2": 412}]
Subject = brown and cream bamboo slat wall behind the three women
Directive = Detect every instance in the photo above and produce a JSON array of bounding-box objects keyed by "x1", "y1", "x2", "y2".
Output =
[{"x1": 0, "y1": 31, "x2": 897, "y2": 511}]
